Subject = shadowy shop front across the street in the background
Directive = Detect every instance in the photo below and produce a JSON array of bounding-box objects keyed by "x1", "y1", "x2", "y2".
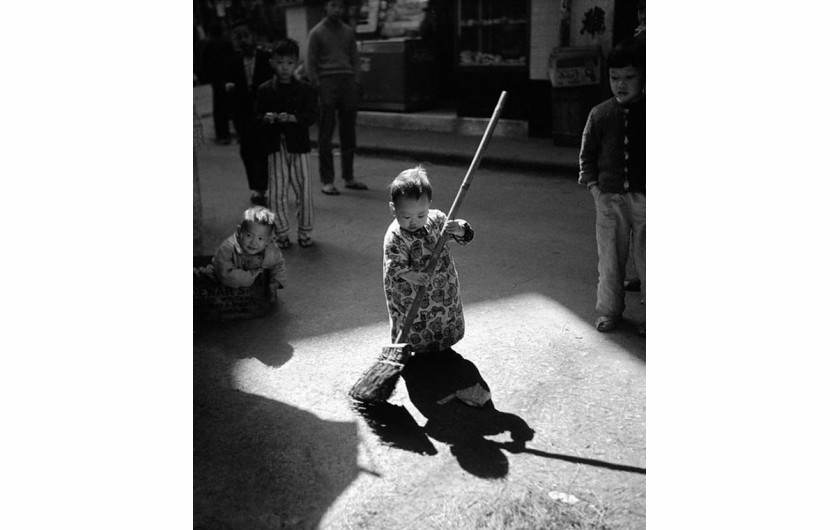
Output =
[{"x1": 223, "y1": 0, "x2": 638, "y2": 142}]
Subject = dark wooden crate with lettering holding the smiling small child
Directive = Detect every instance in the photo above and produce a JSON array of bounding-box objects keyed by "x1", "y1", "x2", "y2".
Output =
[{"x1": 193, "y1": 256, "x2": 271, "y2": 320}]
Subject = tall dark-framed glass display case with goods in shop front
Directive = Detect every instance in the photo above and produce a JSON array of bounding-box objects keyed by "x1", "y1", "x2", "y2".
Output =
[{"x1": 455, "y1": 0, "x2": 530, "y2": 119}]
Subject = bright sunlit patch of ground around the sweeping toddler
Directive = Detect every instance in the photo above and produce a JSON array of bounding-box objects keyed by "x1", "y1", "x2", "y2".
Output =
[{"x1": 230, "y1": 293, "x2": 645, "y2": 528}]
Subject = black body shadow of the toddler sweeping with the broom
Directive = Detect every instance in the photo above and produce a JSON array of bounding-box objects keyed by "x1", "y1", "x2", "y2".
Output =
[{"x1": 402, "y1": 349, "x2": 534, "y2": 478}]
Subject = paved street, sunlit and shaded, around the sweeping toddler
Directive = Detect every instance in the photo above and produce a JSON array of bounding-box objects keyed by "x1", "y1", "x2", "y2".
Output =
[{"x1": 194, "y1": 109, "x2": 645, "y2": 529}]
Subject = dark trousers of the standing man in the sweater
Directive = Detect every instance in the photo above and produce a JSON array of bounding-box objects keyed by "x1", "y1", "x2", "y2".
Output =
[{"x1": 318, "y1": 75, "x2": 359, "y2": 184}]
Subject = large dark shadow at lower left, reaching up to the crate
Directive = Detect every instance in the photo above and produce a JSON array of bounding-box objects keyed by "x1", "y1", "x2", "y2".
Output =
[{"x1": 193, "y1": 318, "x2": 360, "y2": 530}]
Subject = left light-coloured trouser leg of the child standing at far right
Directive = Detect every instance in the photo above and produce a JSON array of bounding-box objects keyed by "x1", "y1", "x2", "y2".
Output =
[{"x1": 595, "y1": 193, "x2": 630, "y2": 318}]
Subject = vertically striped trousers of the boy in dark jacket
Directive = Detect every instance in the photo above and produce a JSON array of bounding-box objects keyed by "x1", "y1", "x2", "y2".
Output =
[{"x1": 268, "y1": 141, "x2": 313, "y2": 239}]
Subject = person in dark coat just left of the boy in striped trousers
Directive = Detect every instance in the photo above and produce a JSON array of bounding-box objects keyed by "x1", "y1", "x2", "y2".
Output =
[{"x1": 225, "y1": 26, "x2": 274, "y2": 205}]
